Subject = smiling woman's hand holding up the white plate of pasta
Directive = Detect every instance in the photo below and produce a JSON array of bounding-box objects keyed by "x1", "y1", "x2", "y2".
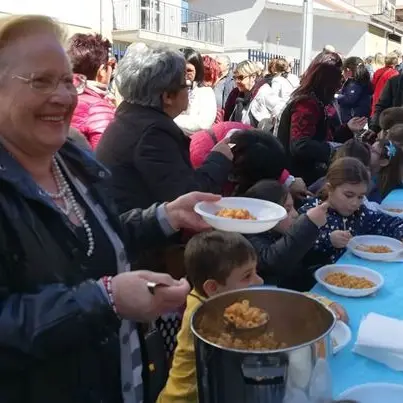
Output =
[{"x1": 165, "y1": 192, "x2": 221, "y2": 231}]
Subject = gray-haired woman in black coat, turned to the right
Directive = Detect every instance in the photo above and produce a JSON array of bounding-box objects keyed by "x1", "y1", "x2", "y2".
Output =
[{"x1": 97, "y1": 44, "x2": 232, "y2": 212}]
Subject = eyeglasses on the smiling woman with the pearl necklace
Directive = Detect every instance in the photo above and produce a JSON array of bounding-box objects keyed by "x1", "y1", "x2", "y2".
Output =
[{"x1": 12, "y1": 73, "x2": 86, "y2": 94}]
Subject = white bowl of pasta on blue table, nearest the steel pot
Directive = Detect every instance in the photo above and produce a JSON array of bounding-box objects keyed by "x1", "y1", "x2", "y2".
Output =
[{"x1": 315, "y1": 264, "x2": 384, "y2": 297}]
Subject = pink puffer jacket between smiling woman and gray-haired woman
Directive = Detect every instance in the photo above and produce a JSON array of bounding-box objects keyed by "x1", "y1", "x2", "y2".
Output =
[{"x1": 71, "y1": 82, "x2": 115, "y2": 150}]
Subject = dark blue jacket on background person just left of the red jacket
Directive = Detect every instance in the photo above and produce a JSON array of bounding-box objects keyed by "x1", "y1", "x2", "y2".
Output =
[{"x1": 337, "y1": 79, "x2": 373, "y2": 123}]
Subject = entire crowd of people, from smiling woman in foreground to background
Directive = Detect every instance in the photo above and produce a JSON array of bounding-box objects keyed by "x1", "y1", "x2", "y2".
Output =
[{"x1": 0, "y1": 11, "x2": 403, "y2": 403}]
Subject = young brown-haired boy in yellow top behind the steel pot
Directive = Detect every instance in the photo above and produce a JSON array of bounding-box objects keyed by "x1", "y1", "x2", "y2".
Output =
[{"x1": 157, "y1": 231, "x2": 348, "y2": 403}]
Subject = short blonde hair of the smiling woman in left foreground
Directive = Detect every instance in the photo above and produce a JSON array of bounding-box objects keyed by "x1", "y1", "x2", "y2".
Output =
[{"x1": 0, "y1": 15, "x2": 67, "y2": 64}]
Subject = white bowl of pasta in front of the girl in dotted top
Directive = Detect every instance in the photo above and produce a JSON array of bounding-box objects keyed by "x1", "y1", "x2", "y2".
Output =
[{"x1": 347, "y1": 235, "x2": 403, "y2": 262}]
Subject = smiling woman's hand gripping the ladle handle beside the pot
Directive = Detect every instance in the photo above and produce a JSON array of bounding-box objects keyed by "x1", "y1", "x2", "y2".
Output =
[{"x1": 112, "y1": 270, "x2": 190, "y2": 322}]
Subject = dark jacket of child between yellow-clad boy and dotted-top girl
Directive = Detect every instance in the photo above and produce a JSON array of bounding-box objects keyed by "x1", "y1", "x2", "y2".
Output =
[{"x1": 248, "y1": 214, "x2": 319, "y2": 291}]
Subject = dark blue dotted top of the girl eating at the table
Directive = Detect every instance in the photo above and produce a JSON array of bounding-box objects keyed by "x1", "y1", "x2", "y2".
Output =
[{"x1": 299, "y1": 198, "x2": 403, "y2": 265}]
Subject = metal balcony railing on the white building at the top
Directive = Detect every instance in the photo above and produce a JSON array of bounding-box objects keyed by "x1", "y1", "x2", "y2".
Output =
[{"x1": 113, "y1": 0, "x2": 224, "y2": 45}]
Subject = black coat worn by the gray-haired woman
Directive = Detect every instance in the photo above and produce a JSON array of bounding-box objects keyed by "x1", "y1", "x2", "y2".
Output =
[{"x1": 96, "y1": 102, "x2": 232, "y2": 212}]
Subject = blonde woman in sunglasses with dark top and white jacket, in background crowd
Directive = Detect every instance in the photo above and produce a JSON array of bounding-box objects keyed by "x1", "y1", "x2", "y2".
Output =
[{"x1": 224, "y1": 60, "x2": 285, "y2": 127}]
